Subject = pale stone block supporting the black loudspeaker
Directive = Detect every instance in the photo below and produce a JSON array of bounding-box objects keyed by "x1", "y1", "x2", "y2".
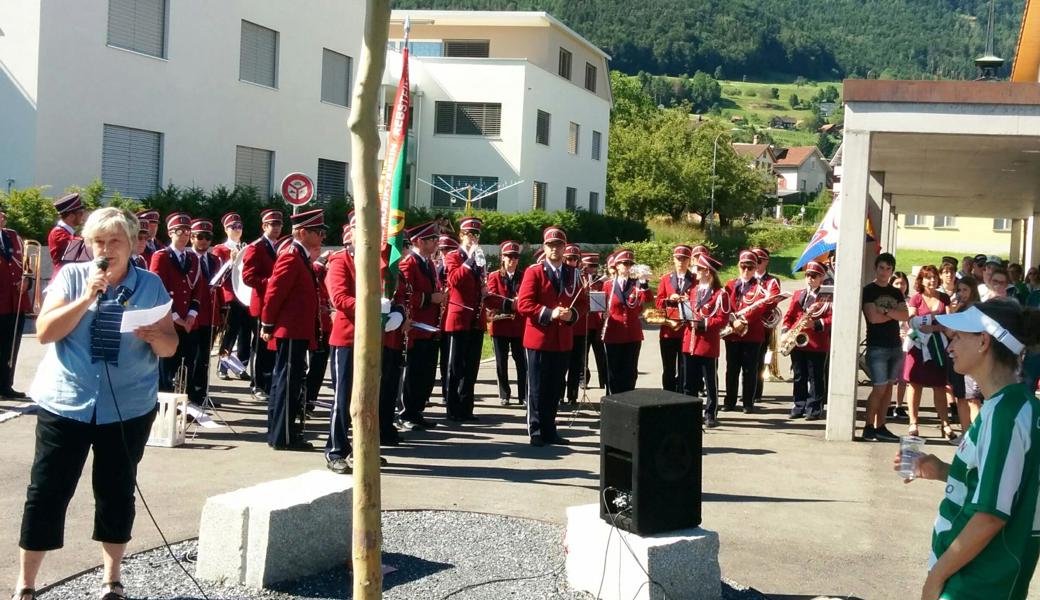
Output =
[{"x1": 564, "y1": 504, "x2": 722, "y2": 600}]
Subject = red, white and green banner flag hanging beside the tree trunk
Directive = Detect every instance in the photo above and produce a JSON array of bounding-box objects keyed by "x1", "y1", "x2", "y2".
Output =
[{"x1": 380, "y1": 46, "x2": 412, "y2": 298}]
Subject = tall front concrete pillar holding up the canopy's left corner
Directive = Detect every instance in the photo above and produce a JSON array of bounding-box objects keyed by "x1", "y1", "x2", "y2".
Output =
[{"x1": 827, "y1": 129, "x2": 883, "y2": 442}]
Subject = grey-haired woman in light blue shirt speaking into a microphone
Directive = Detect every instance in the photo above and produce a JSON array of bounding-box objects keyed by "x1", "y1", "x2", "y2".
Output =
[{"x1": 15, "y1": 208, "x2": 177, "y2": 600}]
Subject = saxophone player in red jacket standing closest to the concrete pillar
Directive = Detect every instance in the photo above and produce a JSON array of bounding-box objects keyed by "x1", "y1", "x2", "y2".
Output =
[{"x1": 781, "y1": 261, "x2": 831, "y2": 421}]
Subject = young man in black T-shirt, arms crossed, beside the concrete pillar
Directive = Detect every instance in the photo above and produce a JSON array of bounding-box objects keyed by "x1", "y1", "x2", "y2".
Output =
[{"x1": 862, "y1": 253, "x2": 910, "y2": 442}]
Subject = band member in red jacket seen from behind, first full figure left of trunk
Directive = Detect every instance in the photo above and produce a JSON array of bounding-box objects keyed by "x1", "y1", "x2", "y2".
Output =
[{"x1": 260, "y1": 208, "x2": 326, "y2": 450}]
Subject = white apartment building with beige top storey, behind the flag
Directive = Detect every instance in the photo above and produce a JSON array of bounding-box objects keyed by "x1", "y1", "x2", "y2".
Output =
[{"x1": 385, "y1": 10, "x2": 612, "y2": 212}]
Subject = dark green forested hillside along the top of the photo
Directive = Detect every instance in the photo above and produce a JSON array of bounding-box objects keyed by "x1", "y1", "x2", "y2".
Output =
[{"x1": 394, "y1": 0, "x2": 1024, "y2": 79}]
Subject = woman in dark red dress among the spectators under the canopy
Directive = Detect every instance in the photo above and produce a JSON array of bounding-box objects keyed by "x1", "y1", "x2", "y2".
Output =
[{"x1": 903, "y1": 265, "x2": 956, "y2": 440}]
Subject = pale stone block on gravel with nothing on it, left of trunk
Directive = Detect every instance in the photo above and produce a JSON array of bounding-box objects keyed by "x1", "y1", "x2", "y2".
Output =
[{"x1": 196, "y1": 471, "x2": 354, "y2": 588}]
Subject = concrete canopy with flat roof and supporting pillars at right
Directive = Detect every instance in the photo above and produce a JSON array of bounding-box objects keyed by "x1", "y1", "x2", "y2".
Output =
[{"x1": 827, "y1": 80, "x2": 1040, "y2": 441}]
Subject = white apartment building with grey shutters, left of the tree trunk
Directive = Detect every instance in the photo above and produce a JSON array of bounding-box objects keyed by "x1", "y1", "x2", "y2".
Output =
[{"x1": 0, "y1": 0, "x2": 365, "y2": 198}]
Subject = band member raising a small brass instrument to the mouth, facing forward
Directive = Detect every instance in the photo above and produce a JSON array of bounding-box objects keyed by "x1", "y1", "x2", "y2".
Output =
[{"x1": 444, "y1": 216, "x2": 486, "y2": 422}]
